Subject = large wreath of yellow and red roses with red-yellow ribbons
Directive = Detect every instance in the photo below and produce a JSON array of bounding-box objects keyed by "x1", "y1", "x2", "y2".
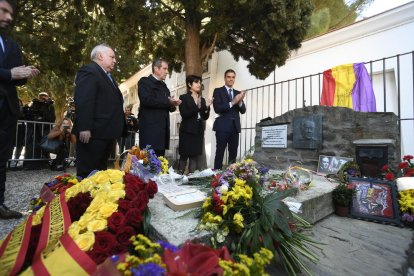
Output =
[{"x1": 0, "y1": 170, "x2": 158, "y2": 275}]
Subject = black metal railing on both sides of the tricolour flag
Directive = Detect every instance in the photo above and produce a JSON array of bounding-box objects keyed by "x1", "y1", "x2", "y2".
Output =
[{"x1": 238, "y1": 51, "x2": 414, "y2": 158}]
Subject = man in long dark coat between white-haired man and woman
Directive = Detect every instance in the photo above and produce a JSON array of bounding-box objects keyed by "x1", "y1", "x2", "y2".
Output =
[{"x1": 138, "y1": 59, "x2": 181, "y2": 156}]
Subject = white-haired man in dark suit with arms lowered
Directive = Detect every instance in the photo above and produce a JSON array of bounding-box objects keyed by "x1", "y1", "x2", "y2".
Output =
[{"x1": 72, "y1": 44, "x2": 126, "y2": 178}]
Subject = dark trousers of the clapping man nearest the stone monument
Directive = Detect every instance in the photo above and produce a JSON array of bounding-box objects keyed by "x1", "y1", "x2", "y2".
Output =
[{"x1": 214, "y1": 127, "x2": 239, "y2": 170}]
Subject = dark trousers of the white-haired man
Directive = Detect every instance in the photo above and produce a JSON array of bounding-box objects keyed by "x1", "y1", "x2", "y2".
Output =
[{"x1": 76, "y1": 138, "x2": 115, "y2": 178}]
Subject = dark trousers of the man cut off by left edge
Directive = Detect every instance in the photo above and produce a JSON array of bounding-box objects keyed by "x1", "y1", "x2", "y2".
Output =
[{"x1": 0, "y1": 102, "x2": 17, "y2": 204}]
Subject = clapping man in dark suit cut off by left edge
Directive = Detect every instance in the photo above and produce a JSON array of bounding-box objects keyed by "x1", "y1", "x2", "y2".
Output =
[{"x1": 0, "y1": 0, "x2": 39, "y2": 219}]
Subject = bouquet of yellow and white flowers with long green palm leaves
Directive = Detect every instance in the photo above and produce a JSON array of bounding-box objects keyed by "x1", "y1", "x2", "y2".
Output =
[{"x1": 196, "y1": 159, "x2": 317, "y2": 274}]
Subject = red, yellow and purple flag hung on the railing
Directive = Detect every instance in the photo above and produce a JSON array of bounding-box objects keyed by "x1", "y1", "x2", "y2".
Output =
[{"x1": 320, "y1": 63, "x2": 377, "y2": 112}]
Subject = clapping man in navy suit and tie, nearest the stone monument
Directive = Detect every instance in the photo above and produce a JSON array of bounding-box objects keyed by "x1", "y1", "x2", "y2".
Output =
[{"x1": 213, "y1": 69, "x2": 246, "y2": 170}]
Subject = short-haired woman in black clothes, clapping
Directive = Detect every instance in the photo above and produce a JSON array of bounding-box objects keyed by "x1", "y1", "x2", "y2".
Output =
[{"x1": 178, "y1": 75, "x2": 211, "y2": 173}]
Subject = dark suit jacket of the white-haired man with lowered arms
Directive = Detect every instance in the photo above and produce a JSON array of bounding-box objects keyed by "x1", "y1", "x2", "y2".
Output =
[{"x1": 72, "y1": 62, "x2": 127, "y2": 139}]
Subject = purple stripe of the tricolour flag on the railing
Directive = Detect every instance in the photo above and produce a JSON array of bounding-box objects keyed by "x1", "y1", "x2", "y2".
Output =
[{"x1": 352, "y1": 63, "x2": 377, "y2": 112}]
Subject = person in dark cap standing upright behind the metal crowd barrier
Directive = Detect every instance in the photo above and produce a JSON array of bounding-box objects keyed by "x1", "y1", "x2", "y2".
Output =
[{"x1": 24, "y1": 92, "x2": 56, "y2": 170}]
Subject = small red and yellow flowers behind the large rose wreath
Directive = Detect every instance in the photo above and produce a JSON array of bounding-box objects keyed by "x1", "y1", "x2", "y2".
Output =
[{"x1": 29, "y1": 173, "x2": 79, "y2": 211}]
